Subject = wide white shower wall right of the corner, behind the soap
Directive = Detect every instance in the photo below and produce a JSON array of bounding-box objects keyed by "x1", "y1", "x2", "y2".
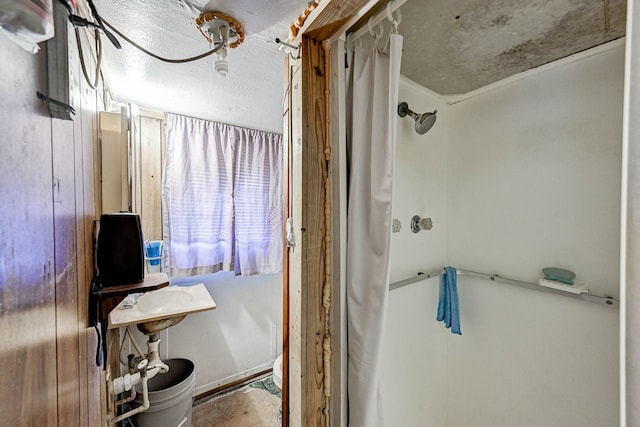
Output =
[{"x1": 447, "y1": 43, "x2": 624, "y2": 427}]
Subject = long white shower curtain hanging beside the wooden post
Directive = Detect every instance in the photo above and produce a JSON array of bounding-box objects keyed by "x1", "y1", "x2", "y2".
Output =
[{"x1": 347, "y1": 34, "x2": 402, "y2": 427}]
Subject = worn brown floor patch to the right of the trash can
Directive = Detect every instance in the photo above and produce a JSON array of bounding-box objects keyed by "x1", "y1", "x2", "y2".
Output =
[{"x1": 191, "y1": 376, "x2": 282, "y2": 427}]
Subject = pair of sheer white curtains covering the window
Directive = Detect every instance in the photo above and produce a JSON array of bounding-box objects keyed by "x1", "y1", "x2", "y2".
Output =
[{"x1": 162, "y1": 114, "x2": 283, "y2": 276}]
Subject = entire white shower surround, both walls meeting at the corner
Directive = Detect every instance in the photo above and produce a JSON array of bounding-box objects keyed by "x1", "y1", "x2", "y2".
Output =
[{"x1": 383, "y1": 42, "x2": 624, "y2": 427}]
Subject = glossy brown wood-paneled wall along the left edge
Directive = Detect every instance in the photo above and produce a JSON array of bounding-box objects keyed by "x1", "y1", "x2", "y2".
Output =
[{"x1": 0, "y1": 18, "x2": 105, "y2": 426}]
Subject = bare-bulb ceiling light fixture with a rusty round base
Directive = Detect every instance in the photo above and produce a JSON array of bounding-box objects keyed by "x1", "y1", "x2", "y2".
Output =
[{"x1": 196, "y1": 12, "x2": 244, "y2": 77}]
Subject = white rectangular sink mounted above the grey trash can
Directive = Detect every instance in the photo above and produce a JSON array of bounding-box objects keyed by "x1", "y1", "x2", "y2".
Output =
[{"x1": 109, "y1": 283, "x2": 216, "y2": 334}]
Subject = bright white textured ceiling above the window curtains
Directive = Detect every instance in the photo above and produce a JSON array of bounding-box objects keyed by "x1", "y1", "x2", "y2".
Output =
[{"x1": 94, "y1": 0, "x2": 307, "y2": 132}]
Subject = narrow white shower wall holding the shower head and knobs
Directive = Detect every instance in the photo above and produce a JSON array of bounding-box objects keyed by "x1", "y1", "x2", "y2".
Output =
[{"x1": 382, "y1": 78, "x2": 448, "y2": 426}]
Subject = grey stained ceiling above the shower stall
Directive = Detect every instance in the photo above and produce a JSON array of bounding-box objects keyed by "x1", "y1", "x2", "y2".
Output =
[{"x1": 399, "y1": 0, "x2": 626, "y2": 94}]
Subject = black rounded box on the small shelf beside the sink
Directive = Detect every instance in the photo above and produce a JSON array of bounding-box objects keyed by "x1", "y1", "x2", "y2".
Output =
[{"x1": 96, "y1": 213, "x2": 144, "y2": 287}]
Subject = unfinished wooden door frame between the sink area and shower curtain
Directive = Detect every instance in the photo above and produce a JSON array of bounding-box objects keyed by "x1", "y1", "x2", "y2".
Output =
[{"x1": 283, "y1": 0, "x2": 378, "y2": 426}]
